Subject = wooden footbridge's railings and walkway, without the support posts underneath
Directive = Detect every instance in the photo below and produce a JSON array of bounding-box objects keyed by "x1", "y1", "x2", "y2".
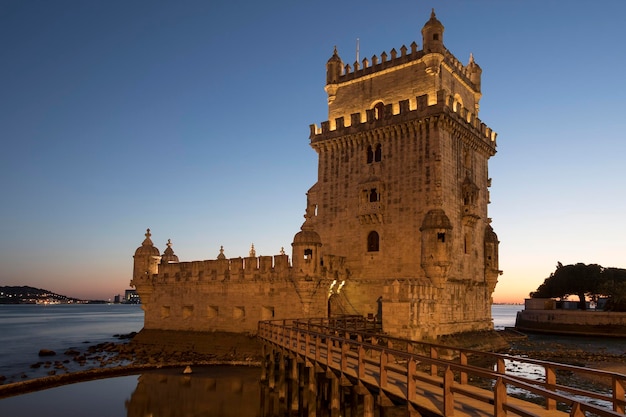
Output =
[{"x1": 258, "y1": 316, "x2": 626, "y2": 417}]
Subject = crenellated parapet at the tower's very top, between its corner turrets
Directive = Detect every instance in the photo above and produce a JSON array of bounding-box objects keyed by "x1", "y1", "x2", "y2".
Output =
[{"x1": 337, "y1": 42, "x2": 480, "y2": 91}]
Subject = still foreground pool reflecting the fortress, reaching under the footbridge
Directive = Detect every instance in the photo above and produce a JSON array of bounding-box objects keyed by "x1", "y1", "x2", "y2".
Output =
[{"x1": 0, "y1": 366, "x2": 406, "y2": 417}]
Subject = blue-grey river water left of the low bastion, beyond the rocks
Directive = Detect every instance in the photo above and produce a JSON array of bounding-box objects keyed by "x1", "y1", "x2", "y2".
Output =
[{"x1": 0, "y1": 304, "x2": 143, "y2": 382}]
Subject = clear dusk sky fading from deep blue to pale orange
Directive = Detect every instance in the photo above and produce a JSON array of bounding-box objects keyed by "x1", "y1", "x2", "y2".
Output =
[{"x1": 0, "y1": 0, "x2": 626, "y2": 302}]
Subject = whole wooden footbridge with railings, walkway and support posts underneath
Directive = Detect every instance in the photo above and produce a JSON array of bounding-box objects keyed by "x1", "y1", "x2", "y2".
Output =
[{"x1": 258, "y1": 316, "x2": 626, "y2": 417}]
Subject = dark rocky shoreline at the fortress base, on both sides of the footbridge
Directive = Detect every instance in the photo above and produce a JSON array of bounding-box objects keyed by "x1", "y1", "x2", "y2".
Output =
[{"x1": 0, "y1": 333, "x2": 626, "y2": 398}]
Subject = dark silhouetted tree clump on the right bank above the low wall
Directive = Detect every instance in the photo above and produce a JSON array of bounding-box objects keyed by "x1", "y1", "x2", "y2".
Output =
[{"x1": 530, "y1": 262, "x2": 608, "y2": 310}]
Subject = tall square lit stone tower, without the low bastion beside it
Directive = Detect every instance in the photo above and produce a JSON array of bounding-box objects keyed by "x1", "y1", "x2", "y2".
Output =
[{"x1": 304, "y1": 11, "x2": 500, "y2": 339}]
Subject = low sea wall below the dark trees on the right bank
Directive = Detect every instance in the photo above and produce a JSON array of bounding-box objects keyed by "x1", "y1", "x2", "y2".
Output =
[{"x1": 515, "y1": 309, "x2": 626, "y2": 337}]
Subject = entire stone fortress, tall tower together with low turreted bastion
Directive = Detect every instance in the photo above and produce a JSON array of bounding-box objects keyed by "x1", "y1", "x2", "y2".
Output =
[{"x1": 131, "y1": 12, "x2": 500, "y2": 340}]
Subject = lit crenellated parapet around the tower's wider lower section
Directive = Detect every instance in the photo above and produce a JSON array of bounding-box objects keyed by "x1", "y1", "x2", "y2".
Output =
[{"x1": 309, "y1": 90, "x2": 497, "y2": 148}]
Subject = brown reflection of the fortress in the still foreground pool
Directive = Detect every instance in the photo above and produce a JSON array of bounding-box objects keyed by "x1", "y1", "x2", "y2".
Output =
[{"x1": 126, "y1": 366, "x2": 407, "y2": 417}]
